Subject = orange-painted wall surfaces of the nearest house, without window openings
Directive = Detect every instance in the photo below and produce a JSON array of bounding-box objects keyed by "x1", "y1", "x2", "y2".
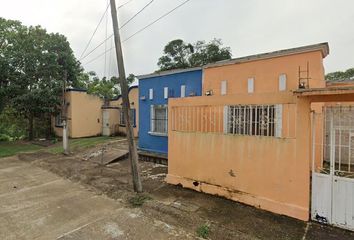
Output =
[{"x1": 166, "y1": 48, "x2": 325, "y2": 221}]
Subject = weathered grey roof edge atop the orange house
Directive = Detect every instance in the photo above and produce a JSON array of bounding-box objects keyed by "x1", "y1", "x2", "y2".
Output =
[{"x1": 205, "y1": 42, "x2": 329, "y2": 68}]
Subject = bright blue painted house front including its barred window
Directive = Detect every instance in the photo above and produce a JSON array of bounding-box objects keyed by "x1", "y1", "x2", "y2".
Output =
[{"x1": 138, "y1": 68, "x2": 202, "y2": 156}]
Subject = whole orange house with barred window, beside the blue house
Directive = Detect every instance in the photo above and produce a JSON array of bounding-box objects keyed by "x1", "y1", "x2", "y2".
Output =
[{"x1": 166, "y1": 43, "x2": 329, "y2": 220}]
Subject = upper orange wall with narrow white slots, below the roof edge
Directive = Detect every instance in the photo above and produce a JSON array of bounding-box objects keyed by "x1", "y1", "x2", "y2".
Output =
[{"x1": 203, "y1": 51, "x2": 325, "y2": 96}]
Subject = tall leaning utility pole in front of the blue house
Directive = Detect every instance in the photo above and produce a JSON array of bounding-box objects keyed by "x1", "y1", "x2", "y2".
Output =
[{"x1": 110, "y1": 0, "x2": 143, "y2": 193}]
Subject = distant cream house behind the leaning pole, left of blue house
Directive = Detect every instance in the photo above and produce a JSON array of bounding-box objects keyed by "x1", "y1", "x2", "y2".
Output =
[{"x1": 52, "y1": 86, "x2": 139, "y2": 138}]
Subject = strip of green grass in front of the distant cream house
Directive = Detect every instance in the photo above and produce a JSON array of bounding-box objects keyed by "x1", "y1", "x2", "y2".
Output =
[{"x1": 0, "y1": 137, "x2": 115, "y2": 158}]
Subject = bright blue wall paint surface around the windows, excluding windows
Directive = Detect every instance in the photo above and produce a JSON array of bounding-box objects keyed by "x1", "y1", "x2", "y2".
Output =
[{"x1": 139, "y1": 70, "x2": 202, "y2": 154}]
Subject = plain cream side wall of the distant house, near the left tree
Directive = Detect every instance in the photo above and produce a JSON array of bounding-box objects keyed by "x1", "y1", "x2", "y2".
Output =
[{"x1": 54, "y1": 91, "x2": 103, "y2": 138}]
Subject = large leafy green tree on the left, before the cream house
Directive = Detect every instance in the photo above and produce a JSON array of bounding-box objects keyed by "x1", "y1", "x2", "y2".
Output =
[{"x1": 0, "y1": 18, "x2": 82, "y2": 140}]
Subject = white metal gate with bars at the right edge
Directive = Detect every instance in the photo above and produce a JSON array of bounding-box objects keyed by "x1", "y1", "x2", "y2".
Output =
[{"x1": 311, "y1": 107, "x2": 354, "y2": 230}]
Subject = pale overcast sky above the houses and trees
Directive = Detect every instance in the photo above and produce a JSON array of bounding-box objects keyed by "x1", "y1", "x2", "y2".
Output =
[{"x1": 0, "y1": 0, "x2": 354, "y2": 79}]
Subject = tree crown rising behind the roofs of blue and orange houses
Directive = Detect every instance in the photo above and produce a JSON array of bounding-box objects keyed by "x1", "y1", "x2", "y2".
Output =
[{"x1": 157, "y1": 39, "x2": 231, "y2": 71}]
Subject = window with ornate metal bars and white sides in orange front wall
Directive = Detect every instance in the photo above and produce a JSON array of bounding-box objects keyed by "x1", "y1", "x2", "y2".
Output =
[{"x1": 224, "y1": 105, "x2": 282, "y2": 137}]
